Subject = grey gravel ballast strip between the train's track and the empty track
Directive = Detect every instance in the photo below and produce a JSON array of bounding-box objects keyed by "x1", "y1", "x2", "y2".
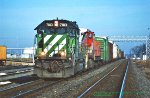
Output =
[{"x1": 37, "y1": 60, "x2": 124, "y2": 98}]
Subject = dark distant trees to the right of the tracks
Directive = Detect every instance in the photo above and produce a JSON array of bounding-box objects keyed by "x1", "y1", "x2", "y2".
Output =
[{"x1": 131, "y1": 44, "x2": 146, "y2": 57}]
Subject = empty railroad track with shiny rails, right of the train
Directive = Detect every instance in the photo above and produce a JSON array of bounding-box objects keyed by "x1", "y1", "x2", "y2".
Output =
[{"x1": 77, "y1": 59, "x2": 128, "y2": 98}]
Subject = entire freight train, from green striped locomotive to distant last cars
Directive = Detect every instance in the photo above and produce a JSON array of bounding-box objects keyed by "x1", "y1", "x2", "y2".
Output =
[{"x1": 34, "y1": 19, "x2": 124, "y2": 78}]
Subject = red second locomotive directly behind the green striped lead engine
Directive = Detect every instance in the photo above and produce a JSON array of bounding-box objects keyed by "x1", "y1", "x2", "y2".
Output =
[{"x1": 82, "y1": 30, "x2": 101, "y2": 70}]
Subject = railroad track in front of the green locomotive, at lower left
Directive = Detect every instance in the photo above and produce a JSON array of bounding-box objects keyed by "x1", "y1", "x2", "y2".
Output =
[{"x1": 0, "y1": 79, "x2": 61, "y2": 98}]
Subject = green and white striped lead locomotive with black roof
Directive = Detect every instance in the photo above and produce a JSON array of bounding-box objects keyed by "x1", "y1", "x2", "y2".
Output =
[{"x1": 34, "y1": 19, "x2": 83, "y2": 78}]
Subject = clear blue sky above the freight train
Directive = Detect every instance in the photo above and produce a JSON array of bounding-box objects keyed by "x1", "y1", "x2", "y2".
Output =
[{"x1": 0, "y1": 0, "x2": 150, "y2": 53}]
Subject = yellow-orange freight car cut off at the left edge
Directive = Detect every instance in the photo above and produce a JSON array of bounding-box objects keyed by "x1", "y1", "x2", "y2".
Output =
[{"x1": 0, "y1": 46, "x2": 6, "y2": 65}]
